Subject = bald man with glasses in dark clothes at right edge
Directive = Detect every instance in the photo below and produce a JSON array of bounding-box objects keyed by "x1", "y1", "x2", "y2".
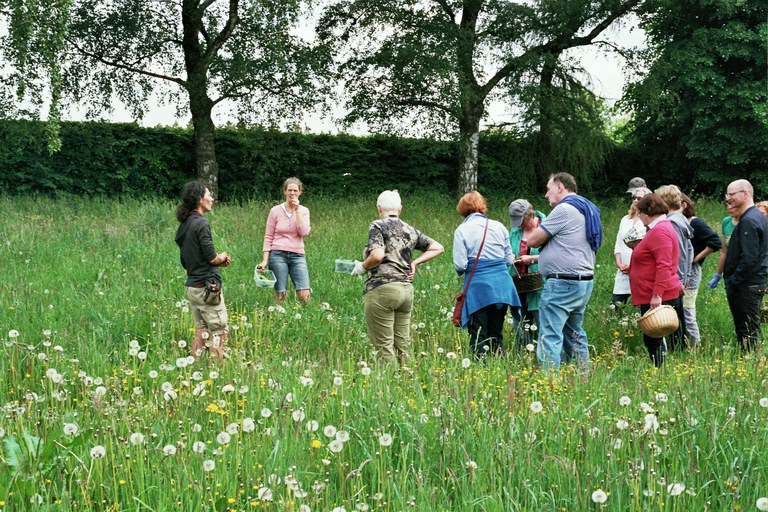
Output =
[{"x1": 723, "y1": 180, "x2": 768, "y2": 351}]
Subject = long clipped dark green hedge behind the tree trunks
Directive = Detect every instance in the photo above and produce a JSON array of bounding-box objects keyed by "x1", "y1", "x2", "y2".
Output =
[{"x1": 0, "y1": 120, "x2": 632, "y2": 200}]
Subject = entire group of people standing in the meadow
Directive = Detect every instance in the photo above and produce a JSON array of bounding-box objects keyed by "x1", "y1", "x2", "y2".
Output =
[{"x1": 176, "y1": 173, "x2": 768, "y2": 372}]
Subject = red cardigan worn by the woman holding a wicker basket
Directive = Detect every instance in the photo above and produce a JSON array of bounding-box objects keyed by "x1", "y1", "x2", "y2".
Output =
[{"x1": 629, "y1": 219, "x2": 680, "y2": 306}]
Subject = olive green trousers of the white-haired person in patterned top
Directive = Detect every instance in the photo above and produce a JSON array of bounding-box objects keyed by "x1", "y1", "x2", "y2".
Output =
[{"x1": 363, "y1": 283, "x2": 413, "y2": 363}]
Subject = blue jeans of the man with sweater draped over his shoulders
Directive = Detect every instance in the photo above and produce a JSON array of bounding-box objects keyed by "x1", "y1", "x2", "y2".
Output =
[{"x1": 536, "y1": 279, "x2": 595, "y2": 372}]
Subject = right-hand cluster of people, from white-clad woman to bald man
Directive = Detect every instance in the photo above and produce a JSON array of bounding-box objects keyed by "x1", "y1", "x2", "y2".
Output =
[{"x1": 611, "y1": 178, "x2": 768, "y2": 366}]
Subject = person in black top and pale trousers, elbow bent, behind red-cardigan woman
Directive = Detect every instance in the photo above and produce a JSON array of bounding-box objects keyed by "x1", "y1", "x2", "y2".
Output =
[{"x1": 681, "y1": 194, "x2": 723, "y2": 347}]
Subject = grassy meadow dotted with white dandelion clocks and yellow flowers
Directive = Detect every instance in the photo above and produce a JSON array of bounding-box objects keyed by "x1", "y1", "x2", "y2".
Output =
[{"x1": 0, "y1": 192, "x2": 768, "y2": 512}]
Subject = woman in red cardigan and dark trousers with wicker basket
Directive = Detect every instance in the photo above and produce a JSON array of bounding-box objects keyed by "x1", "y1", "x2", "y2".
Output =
[{"x1": 629, "y1": 194, "x2": 682, "y2": 367}]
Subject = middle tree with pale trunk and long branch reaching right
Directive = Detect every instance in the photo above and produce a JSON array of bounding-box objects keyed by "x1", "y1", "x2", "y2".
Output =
[{"x1": 319, "y1": 0, "x2": 640, "y2": 192}]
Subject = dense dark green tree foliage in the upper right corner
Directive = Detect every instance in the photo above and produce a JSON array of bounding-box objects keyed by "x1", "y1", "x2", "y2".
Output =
[{"x1": 626, "y1": 0, "x2": 768, "y2": 192}]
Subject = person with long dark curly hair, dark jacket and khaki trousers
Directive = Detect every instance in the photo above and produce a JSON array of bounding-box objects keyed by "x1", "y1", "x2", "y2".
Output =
[{"x1": 176, "y1": 181, "x2": 232, "y2": 361}]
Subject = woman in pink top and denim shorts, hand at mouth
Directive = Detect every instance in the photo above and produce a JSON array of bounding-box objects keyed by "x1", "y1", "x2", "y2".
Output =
[{"x1": 256, "y1": 178, "x2": 311, "y2": 302}]
